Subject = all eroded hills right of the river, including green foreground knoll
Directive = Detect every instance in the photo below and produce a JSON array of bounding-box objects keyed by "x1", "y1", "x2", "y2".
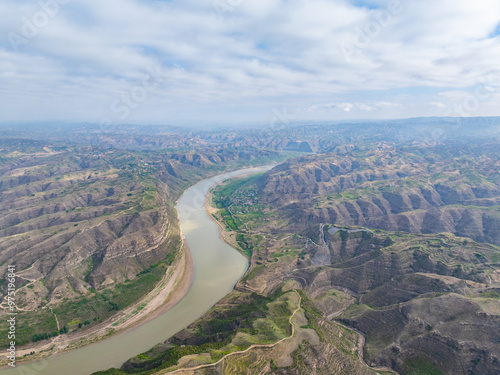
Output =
[{"x1": 111, "y1": 142, "x2": 500, "y2": 375}]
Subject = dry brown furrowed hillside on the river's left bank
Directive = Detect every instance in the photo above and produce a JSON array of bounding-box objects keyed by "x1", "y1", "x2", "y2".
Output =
[{"x1": 0, "y1": 148, "x2": 175, "y2": 310}]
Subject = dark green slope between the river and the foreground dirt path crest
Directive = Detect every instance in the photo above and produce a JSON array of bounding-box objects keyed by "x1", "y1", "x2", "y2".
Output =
[{"x1": 94, "y1": 292, "x2": 296, "y2": 375}]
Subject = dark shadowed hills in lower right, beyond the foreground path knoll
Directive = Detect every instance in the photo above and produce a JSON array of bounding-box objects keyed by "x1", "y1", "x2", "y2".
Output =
[{"x1": 290, "y1": 231, "x2": 500, "y2": 374}]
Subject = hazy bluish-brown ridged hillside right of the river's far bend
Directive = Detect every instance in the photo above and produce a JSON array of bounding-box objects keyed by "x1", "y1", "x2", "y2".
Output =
[{"x1": 257, "y1": 146, "x2": 500, "y2": 245}]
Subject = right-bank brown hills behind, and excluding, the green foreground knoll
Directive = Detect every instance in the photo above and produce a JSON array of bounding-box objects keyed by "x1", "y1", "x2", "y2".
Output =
[{"x1": 204, "y1": 144, "x2": 500, "y2": 375}]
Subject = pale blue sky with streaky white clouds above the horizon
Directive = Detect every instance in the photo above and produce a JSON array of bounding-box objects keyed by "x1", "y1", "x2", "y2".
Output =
[{"x1": 0, "y1": 0, "x2": 500, "y2": 125}]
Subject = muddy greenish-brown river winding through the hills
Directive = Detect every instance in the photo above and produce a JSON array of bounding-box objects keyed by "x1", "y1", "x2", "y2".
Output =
[{"x1": 0, "y1": 166, "x2": 272, "y2": 375}]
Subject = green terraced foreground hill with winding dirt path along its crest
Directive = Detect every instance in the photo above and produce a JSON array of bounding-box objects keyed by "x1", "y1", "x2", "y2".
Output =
[{"x1": 98, "y1": 290, "x2": 393, "y2": 375}]
